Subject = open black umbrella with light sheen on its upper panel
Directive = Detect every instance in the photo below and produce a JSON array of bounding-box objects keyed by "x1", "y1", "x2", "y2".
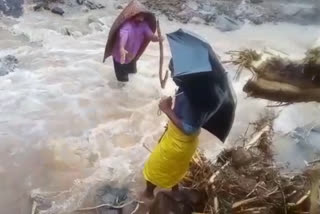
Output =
[{"x1": 167, "y1": 29, "x2": 236, "y2": 141}]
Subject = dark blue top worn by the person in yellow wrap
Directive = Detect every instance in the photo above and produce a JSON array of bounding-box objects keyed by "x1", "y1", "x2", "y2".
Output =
[{"x1": 173, "y1": 91, "x2": 209, "y2": 135}]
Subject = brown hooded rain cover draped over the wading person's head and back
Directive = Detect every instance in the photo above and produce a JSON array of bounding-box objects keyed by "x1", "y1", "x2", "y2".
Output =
[{"x1": 103, "y1": 0, "x2": 156, "y2": 62}]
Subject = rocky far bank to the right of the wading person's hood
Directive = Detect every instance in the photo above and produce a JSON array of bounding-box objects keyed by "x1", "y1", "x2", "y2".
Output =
[{"x1": 144, "y1": 0, "x2": 320, "y2": 31}]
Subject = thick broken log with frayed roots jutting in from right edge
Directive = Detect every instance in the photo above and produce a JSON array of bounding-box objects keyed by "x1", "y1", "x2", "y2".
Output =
[{"x1": 226, "y1": 47, "x2": 320, "y2": 103}]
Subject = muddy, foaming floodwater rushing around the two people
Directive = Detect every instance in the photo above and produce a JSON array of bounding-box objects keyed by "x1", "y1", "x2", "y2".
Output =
[{"x1": 0, "y1": 1, "x2": 320, "y2": 214}]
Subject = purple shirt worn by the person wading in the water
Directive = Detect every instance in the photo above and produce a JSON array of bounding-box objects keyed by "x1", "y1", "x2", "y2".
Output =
[{"x1": 112, "y1": 20, "x2": 153, "y2": 64}]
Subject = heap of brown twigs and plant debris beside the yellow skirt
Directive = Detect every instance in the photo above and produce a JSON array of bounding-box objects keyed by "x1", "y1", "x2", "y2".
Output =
[{"x1": 182, "y1": 116, "x2": 312, "y2": 214}]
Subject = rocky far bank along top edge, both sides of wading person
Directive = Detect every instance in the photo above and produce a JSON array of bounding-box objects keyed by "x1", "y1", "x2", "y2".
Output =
[{"x1": 0, "y1": 0, "x2": 320, "y2": 31}]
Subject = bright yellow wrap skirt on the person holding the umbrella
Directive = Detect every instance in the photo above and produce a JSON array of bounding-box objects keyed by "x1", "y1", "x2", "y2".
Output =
[{"x1": 143, "y1": 122, "x2": 200, "y2": 188}]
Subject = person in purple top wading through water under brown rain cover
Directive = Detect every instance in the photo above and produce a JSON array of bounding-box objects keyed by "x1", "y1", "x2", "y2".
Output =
[{"x1": 103, "y1": 0, "x2": 163, "y2": 82}]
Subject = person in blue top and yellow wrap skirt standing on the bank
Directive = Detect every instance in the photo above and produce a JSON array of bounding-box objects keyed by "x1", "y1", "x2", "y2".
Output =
[{"x1": 142, "y1": 60, "x2": 214, "y2": 199}]
